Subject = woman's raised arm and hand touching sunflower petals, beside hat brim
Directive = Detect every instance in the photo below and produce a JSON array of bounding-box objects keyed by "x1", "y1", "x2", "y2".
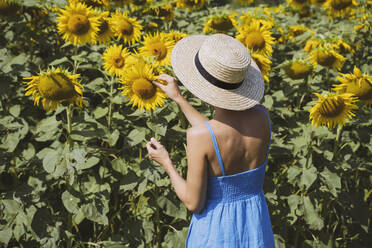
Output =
[{"x1": 153, "y1": 74, "x2": 208, "y2": 126}]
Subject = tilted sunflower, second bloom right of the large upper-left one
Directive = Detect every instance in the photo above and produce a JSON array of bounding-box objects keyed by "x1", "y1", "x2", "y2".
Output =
[{"x1": 110, "y1": 10, "x2": 142, "y2": 45}]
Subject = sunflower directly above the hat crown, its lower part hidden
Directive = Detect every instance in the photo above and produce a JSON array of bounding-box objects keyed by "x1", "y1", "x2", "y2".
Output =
[{"x1": 203, "y1": 13, "x2": 237, "y2": 33}]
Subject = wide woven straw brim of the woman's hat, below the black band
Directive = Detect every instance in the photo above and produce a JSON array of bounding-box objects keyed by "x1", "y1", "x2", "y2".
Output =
[{"x1": 171, "y1": 35, "x2": 265, "y2": 110}]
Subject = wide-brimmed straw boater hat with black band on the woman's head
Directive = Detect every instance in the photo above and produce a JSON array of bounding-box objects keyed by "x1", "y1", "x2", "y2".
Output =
[{"x1": 171, "y1": 34, "x2": 264, "y2": 110}]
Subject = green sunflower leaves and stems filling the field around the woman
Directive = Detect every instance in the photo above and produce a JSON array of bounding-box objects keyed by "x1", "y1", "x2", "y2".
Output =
[{"x1": 0, "y1": 0, "x2": 372, "y2": 248}]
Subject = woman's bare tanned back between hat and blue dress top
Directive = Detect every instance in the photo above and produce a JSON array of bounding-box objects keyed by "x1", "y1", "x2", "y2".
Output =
[{"x1": 201, "y1": 105, "x2": 270, "y2": 177}]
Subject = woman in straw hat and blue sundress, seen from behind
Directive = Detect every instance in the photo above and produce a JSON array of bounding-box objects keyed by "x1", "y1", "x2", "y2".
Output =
[{"x1": 147, "y1": 34, "x2": 274, "y2": 248}]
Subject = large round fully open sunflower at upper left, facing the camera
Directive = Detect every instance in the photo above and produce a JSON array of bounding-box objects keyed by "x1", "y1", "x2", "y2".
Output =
[{"x1": 57, "y1": 3, "x2": 100, "y2": 45}]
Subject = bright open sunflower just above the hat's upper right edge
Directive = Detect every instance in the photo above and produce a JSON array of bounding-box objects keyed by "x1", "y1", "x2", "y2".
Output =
[{"x1": 236, "y1": 20, "x2": 274, "y2": 56}]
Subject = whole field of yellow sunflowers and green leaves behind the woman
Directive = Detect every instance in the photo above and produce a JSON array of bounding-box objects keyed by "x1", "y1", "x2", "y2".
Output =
[{"x1": 0, "y1": 0, "x2": 372, "y2": 248}]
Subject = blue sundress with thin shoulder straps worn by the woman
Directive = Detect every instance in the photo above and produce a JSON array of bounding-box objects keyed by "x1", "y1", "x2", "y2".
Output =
[{"x1": 186, "y1": 105, "x2": 275, "y2": 248}]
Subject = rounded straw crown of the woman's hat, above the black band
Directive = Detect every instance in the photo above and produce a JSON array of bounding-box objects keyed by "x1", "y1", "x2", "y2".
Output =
[{"x1": 198, "y1": 34, "x2": 251, "y2": 84}]
